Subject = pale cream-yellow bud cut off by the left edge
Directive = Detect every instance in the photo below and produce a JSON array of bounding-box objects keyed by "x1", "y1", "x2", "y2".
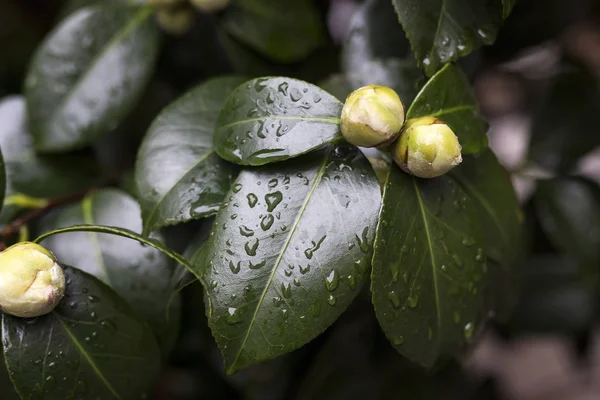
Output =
[{"x1": 0, "y1": 242, "x2": 65, "y2": 318}]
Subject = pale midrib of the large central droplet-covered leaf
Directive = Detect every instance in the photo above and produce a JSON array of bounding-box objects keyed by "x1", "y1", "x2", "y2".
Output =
[{"x1": 228, "y1": 145, "x2": 335, "y2": 372}]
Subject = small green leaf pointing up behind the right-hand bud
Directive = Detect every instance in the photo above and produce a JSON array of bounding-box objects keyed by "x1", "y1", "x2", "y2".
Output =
[{"x1": 406, "y1": 64, "x2": 488, "y2": 154}]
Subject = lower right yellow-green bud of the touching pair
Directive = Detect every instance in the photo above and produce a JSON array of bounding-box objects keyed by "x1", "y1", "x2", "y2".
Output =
[{"x1": 393, "y1": 117, "x2": 462, "y2": 178}]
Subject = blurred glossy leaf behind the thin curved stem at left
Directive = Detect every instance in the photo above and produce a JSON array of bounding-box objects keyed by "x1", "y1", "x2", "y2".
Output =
[{"x1": 38, "y1": 189, "x2": 179, "y2": 354}]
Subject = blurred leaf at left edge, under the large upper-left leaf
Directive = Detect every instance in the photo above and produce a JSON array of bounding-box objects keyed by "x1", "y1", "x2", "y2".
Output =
[{"x1": 0, "y1": 96, "x2": 97, "y2": 219}]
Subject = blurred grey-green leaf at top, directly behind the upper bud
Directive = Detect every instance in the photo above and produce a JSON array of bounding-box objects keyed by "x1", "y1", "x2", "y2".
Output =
[{"x1": 342, "y1": 0, "x2": 423, "y2": 104}]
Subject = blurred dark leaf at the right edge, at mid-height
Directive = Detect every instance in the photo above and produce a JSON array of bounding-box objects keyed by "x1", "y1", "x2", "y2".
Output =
[{"x1": 534, "y1": 178, "x2": 600, "y2": 283}]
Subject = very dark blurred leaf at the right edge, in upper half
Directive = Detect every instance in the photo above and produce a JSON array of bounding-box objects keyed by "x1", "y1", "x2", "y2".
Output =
[{"x1": 529, "y1": 64, "x2": 600, "y2": 172}]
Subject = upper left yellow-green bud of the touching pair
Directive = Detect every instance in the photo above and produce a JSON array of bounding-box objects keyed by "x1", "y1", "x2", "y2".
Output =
[{"x1": 340, "y1": 85, "x2": 405, "y2": 147}]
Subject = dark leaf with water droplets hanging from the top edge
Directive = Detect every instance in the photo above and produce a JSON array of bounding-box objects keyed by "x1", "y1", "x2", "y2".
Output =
[{"x1": 392, "y1": 0, "x2": 509, "y2": 76}]
